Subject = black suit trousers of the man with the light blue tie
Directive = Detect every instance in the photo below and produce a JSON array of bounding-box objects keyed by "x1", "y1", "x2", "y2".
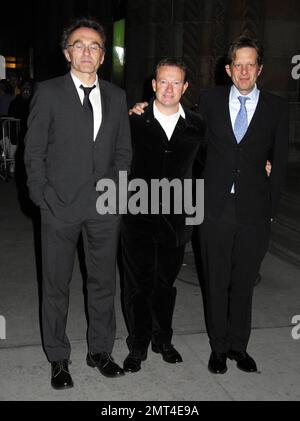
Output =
[{"x1": 200, "y1": 195, "x2": 270, "y2": 352}]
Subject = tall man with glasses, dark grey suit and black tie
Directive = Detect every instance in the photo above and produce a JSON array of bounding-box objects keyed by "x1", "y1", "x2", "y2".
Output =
[{"x1": 25, "y1": 18, "x2": 131, "y2": 389}]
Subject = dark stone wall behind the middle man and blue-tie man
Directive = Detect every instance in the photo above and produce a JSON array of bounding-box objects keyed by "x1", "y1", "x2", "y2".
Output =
[{"x1": 126, "y1": 0, "x2": 300, "y2": 159}]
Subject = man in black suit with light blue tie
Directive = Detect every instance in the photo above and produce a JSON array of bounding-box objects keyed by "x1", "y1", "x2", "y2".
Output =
[{"x1": 199, "y1": 36, "x2": 288, "y2": 373}]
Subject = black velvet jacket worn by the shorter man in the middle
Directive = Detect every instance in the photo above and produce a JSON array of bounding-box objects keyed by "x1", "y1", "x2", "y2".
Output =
[{"x1": 123, "y1": 102, "x2": 205, "y2": 247}]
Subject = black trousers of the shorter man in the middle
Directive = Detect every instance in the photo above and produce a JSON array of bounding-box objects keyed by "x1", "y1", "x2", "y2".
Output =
[{"x1": 121, "y1": 226, "x2": 185, "y2": 352}]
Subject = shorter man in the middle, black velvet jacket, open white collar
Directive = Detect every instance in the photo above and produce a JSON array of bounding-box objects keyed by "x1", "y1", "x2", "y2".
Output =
[{"x1": 121, "y1": 58, "x2": 205, "y2": 372}]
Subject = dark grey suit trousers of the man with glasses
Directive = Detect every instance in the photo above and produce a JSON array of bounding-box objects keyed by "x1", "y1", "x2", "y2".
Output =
[{"x1": 41, "y1": 204, "x2": 120, "y2": 362}]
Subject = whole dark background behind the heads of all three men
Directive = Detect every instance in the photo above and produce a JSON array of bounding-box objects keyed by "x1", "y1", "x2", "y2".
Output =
[{"x1": 0, "y1": 0, "x2": 300, "y2": 133}]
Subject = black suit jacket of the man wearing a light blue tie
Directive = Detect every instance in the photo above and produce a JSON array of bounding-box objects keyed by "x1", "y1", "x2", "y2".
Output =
[{"x1": 199, "y1": 87, "x2": 288, "y2": 224}]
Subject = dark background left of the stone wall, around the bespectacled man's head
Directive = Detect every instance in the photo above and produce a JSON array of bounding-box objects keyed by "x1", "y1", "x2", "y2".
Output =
[{"x1": 0, "y1": 0, "x2": 126, "y2": 81}]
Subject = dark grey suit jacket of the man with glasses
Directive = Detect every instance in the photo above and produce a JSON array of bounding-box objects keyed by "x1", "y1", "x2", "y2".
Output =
[{"x1": 25, "y1": 73, "x2": 131, "y2": 222}]
